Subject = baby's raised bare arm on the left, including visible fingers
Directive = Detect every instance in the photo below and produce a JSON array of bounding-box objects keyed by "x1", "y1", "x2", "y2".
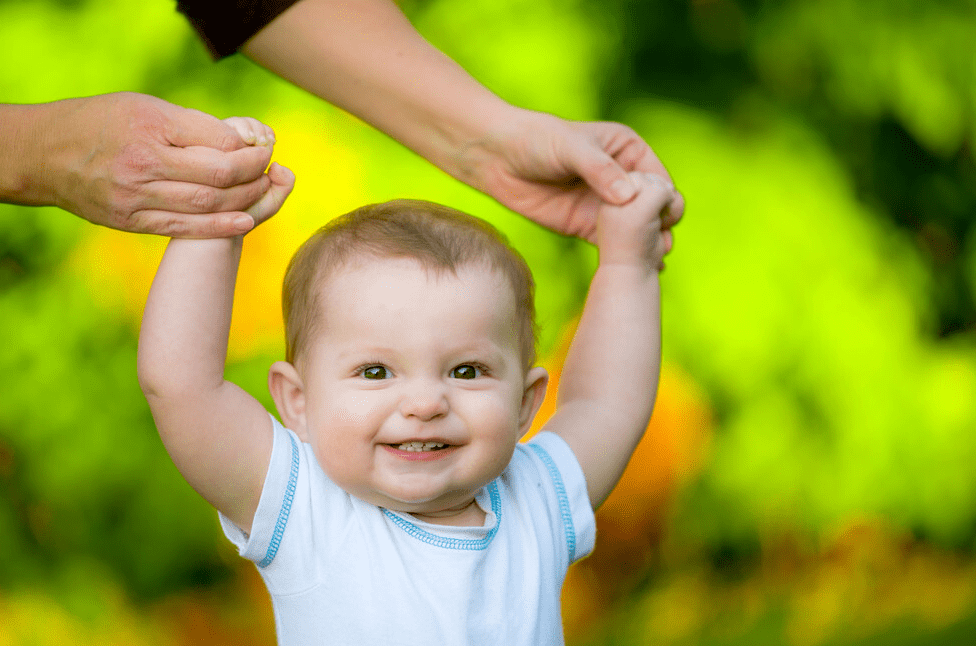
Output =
[{"x1": 138, "y1": 119, "x2": 294, "y2": 531}]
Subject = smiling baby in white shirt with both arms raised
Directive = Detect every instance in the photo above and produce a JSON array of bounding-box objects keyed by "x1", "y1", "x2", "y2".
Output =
[{"x1": 139, "y1": 119, "x2": 675, "y2": 646}]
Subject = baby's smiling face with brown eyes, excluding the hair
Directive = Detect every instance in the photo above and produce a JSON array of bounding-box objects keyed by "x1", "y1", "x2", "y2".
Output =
[{"x1": 295, "y1": 259, "x2": 545, "y2": 515}]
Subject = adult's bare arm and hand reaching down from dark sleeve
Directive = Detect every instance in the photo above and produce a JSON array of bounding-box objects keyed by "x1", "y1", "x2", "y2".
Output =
[{"x1": 242, "y1": 0, "x2": 683, "y2": 242}]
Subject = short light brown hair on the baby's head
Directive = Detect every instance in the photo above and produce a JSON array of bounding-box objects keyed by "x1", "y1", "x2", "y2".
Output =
[{"x1": 281, "y1": 200, "x2": 536, "y2": 370}]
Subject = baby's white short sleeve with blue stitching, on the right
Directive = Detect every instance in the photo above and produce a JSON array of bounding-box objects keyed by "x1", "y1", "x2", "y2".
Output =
[{"x1": 528, "y1": 432, "x2": 596, "y2": 563}]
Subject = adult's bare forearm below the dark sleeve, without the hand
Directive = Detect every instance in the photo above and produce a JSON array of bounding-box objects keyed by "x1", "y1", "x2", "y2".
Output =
[{"x1": 242, "y1": 0, "x2": 523, "y2": 180}]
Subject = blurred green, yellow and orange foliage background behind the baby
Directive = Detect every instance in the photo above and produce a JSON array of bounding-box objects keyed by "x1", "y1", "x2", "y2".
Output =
[{"x1": 0, "y1": 0, "x2": 976, "y2": 646}]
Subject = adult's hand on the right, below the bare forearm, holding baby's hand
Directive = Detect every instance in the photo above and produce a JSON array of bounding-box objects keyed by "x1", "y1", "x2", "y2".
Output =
[{"x1": 459, "y1": 112, "x2": 684, "y2": 243}]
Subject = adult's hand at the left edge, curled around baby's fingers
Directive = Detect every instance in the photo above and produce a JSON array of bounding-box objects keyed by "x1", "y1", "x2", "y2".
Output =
[{"x1": 0, "y1": 93, "x2": 271, "y2": 238}]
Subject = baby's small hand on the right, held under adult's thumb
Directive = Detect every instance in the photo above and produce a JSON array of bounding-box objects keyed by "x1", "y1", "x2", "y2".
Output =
[{"x1": 597, "y1": 172, "x2": 677, "y2": 270}]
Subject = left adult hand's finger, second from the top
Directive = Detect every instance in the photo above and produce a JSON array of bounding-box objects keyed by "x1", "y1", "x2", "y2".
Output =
[{"x1": 159, "y1": 146, "x2": 271, "y2": 188}]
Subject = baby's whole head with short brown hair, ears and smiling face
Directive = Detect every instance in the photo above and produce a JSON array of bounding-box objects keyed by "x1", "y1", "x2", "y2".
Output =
[{"x1": 270, "y1": 200, "x2": 547, "y2": 517}]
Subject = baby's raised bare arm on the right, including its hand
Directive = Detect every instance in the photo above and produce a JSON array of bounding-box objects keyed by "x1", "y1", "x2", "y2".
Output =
[{"x1": 546, "y1": 173, "x2": 675, "y2": 509}]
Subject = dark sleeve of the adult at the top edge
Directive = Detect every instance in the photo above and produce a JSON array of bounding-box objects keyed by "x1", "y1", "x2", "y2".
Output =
[{"x1": 176, "y1": 0, "x2": 298, "y2": 59}]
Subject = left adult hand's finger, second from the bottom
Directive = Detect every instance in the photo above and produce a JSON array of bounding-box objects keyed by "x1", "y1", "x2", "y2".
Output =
[{"x1": 141, "y1": 174, "x2": 271, "y2": 213}]
